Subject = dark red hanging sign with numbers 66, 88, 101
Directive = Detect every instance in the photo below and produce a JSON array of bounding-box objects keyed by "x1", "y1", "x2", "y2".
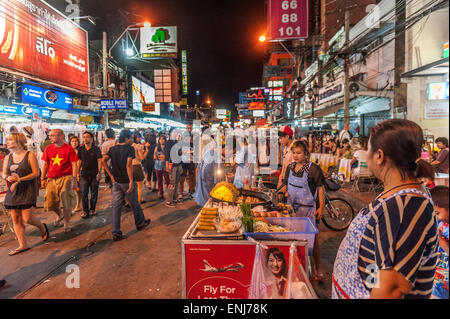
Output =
[{"x1": 267, "y1": 0, "x2": 309, "y2": 40}]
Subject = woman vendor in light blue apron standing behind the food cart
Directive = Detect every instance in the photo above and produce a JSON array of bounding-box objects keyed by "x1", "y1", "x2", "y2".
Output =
[{"x1": 281, "y1": 141, "x2": 325, "y2": 281}]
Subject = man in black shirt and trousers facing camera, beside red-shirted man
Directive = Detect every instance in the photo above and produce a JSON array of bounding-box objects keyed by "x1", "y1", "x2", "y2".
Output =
[{"x1": 78, "y1": 132, "x2": 102, "y2": 218}]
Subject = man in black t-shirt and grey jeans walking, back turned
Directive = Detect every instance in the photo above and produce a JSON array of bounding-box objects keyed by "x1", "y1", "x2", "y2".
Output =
[{"x1": 103, "y1": 130, "x2": 150, "y2": 241}]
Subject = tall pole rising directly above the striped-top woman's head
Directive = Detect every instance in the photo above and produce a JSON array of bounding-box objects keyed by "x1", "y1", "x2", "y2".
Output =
[{"x1": 393, "y1": 0, "x2": 407, "y2": 117}]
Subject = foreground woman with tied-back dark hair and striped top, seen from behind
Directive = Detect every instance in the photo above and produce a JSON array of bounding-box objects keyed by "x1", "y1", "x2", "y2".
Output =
[{"x1": 332, "y1": 120, "x2": 438, "y2": 299}]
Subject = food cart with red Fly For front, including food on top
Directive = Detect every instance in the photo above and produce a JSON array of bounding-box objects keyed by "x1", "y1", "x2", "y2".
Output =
[{"x1": 181, "y1": 182, "x2": 317, "y2": 299}]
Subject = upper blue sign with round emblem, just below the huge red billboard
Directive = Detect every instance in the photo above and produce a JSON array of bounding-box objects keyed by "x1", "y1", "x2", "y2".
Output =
[{"x1": 22, "y1": 84, "x2": 73, "y2": 110}]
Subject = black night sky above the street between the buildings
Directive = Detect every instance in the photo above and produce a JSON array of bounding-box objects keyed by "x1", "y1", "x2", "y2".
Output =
[{"x1": 76, "y1": 0, "x2": 266, "y2": 107}]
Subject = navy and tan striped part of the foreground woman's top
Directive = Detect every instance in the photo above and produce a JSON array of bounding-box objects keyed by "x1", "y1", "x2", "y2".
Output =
[{"x1": 358, "y1": 194, "x2": 439, "y2": 298}]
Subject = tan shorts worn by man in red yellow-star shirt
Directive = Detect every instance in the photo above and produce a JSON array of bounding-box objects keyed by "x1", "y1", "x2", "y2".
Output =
[{"x1": 44, "y1": 175, "x2": 77, "y2": 212}]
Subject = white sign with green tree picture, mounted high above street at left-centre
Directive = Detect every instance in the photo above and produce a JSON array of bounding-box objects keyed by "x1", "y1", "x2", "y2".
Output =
[{"x1": 141, "y1": 26, "x2": 178, "y2": 59}]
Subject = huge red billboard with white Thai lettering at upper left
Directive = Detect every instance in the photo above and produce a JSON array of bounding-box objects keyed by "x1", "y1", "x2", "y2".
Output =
[{"x1": 0, "y1": 0, "x2": 89, "y2": 93}]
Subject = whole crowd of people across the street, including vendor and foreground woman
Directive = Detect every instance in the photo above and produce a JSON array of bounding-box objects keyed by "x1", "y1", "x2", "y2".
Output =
[{"x1": 3, "y1": 120, "x2": 448, "y2": 298}]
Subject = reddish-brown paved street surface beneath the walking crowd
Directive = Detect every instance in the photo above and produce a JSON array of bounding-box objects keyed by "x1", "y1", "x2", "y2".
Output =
[{"x1": 0, "y1": 187, "x2": 370, "y2": 299}]
